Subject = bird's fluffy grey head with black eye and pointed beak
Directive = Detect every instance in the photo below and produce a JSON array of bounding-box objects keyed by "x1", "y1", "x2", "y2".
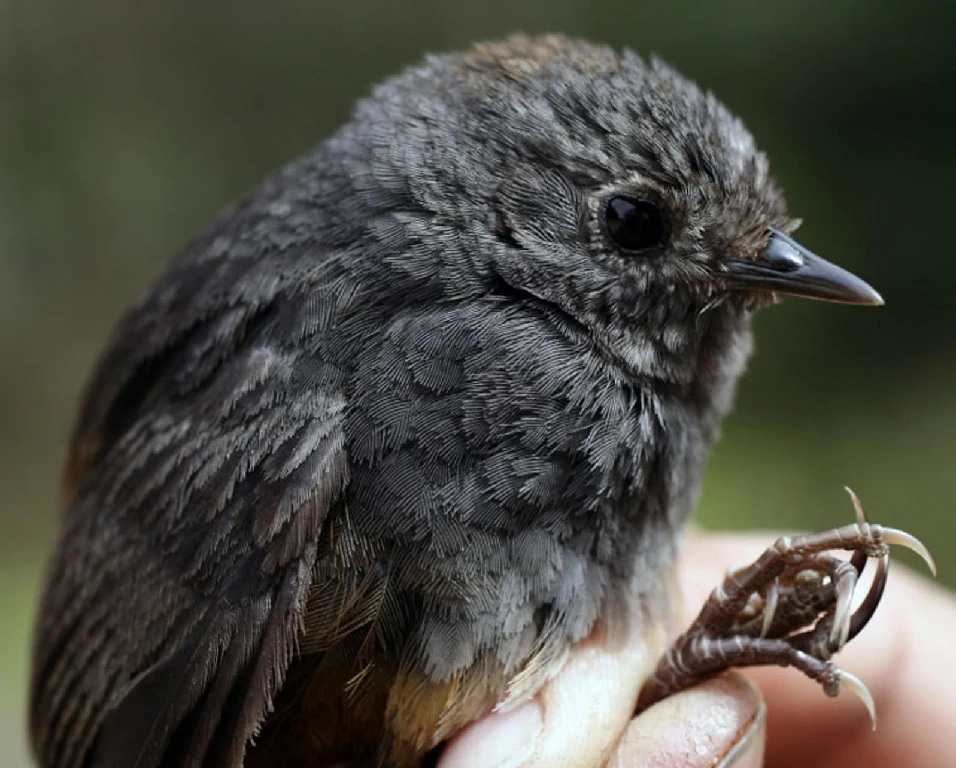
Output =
[{"x1": 336, "y1": 36, "x2": 882, "y2": 381}]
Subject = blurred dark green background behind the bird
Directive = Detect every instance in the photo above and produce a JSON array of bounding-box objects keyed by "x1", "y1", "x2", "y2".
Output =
[{"x1": 0, "y1": 0, "x2": 956, "y2": 768}]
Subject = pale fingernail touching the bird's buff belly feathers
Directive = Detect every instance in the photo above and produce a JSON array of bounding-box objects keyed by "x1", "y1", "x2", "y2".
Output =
[{"x1": 438, "y1": 699, "x2": 544, "y2": 768}]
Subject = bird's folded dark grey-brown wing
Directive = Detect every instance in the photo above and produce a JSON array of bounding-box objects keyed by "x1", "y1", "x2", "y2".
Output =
[{"x1": 30, "y1": 220, "x2": 358, "y2": 768}]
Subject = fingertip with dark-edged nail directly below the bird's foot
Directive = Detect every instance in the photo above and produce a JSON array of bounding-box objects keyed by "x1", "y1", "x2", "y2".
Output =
[{"x1": 609, "y1": 673, "x2": 766, "y2": 768}]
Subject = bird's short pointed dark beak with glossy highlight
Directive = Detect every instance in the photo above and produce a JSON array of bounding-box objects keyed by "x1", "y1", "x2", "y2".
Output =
[{"x1": 724, "y1": 229, "x2": 883, "y2": 306}]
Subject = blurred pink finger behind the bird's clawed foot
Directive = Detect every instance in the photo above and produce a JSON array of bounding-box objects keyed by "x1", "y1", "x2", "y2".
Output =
[{"x1": 681, "y1": 533, "x2": 956, "y2": 768}]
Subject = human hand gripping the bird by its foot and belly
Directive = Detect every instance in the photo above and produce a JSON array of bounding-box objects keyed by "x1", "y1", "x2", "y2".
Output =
[{"x1": 439, "y1": 532, "x2": 956, "y2": 768}]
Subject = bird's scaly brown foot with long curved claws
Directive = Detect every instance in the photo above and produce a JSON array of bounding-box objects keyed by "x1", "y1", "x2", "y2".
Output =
[{"x1": 638, "y1": 489, "x2": 936, "y2": 727}]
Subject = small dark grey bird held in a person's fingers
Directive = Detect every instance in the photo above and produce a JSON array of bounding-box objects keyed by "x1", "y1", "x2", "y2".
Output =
[{"x1": 30, "y1": 37, "x2": 928, "y2": 768}]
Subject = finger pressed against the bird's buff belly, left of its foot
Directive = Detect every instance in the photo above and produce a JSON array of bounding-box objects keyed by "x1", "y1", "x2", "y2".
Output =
[{"x1": 438, "y1": 623, "x2": 665, "y2": 768}]
